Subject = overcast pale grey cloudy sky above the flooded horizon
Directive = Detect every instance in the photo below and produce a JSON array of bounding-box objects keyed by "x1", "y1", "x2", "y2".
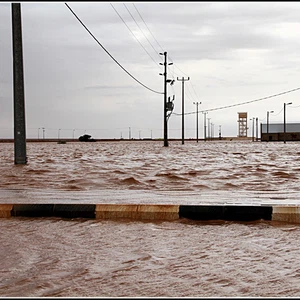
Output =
[{"x1": 0, "y1": 1, "x2": 300, "y2": 138}]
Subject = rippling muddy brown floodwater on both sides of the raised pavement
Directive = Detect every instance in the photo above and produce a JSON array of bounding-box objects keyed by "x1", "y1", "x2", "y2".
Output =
[{"x1": 0, "y1": 141, "x2": 300, "y2": 297}]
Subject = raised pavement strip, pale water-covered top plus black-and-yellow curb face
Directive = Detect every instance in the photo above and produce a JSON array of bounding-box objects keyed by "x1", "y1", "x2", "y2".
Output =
[{"x1": 0, "y1": 189, "x2": 300, "y2": 223}]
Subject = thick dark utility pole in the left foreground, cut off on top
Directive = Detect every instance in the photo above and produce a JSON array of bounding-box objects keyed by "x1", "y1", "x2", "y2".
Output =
[{"x1": 11, "y1": 3, "x2": 27, "y2": 164}]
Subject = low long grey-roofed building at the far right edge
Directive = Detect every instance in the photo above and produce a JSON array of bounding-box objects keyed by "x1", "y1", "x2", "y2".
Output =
[{"x1": 260, "y1": 123, "x2": 300, "y2": 142}]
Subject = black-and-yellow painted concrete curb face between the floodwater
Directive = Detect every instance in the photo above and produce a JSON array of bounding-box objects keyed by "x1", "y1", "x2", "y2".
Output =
[{"x1": 0, "y1": 204, "x2": 300, "y2": 223}]
